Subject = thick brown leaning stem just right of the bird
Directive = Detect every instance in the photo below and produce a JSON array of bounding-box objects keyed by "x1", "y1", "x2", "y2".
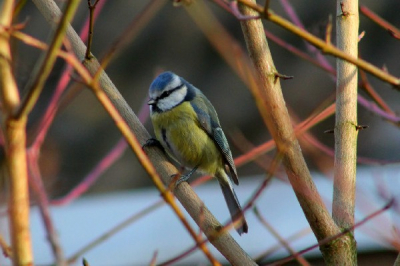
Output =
[{"x1": 240, "y1": 2, "x2": 339, "y2": 247}]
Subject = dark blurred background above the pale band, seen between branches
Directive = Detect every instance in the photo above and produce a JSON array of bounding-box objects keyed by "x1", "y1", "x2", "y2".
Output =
[{"x1": 0, "y1": 0, "x2": 400, "y2": 264}]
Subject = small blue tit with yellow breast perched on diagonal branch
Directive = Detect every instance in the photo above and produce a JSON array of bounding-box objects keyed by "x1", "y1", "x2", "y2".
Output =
[{"x1": 148, "y1": 72, "x2": 248, "y2": 234}]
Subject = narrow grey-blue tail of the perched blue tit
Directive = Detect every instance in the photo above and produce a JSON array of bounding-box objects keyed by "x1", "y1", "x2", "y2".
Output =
[{"x1": 219, "y1": 180, "x2": 248, "y2": 235}]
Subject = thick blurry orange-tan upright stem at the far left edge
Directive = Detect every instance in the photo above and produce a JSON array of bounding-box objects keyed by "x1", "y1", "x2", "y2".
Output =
[{"x1": 0, "y1": 0, "x2": 33, "y2": 265}]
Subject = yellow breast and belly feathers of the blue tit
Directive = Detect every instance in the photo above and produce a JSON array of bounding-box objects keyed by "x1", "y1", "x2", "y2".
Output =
[{"x1": 151, "y1": 102, "x2": 224, "y2": 175}]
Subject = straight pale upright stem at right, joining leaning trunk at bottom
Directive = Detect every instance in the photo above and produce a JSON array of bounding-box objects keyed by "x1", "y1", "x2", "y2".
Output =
[{"x1": 332, "y1": 0, "x2": 359, "y2": 263}]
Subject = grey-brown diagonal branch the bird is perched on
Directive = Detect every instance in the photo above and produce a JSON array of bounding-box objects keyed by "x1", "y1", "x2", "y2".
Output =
[{"x1": 33, "y1": 0, "x2": 254, "y2": 265}]
